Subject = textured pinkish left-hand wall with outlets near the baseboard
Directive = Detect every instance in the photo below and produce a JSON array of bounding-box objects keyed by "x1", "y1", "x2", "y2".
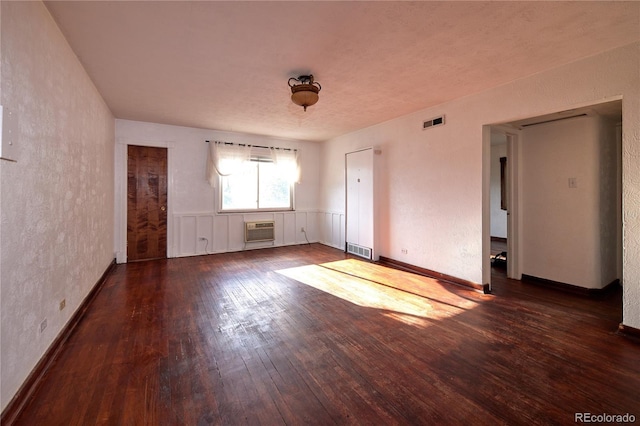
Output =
[{"x1": 0, "y1": 2, "x2": 114, "y2": 409}]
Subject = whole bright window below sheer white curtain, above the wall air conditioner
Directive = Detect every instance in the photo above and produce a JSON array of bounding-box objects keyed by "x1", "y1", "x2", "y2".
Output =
[{"x1": 220, "y1": 157, "x2": 293, "y2": 211}]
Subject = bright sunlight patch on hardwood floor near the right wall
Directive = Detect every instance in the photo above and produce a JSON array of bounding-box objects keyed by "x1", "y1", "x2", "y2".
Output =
[{"x1": 277, "y1": 259, "x2": 477, "y2": 327}]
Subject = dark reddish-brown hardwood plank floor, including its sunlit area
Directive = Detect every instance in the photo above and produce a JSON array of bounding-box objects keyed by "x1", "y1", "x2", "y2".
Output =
[{"x1": 7, "y1": 244, "x2": 640, "y2": 425}]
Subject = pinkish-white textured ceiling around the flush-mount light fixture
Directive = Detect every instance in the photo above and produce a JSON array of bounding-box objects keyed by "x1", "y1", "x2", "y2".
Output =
[{"x1": 46, "y1": 1, "x2": 640, "y2": 141}]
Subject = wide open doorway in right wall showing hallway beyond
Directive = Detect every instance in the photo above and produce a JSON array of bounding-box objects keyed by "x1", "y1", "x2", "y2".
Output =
[{"x1": 483, "y1": 100, "x2": 622, "y2": 293}]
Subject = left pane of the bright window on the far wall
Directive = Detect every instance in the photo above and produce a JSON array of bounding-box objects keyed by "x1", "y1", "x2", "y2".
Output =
[{"x1": 221, "y1": 161, "x2": 258, "y2": 210}]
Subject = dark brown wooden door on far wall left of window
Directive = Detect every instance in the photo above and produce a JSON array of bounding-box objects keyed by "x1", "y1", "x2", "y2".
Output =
[{"x1": 127, "y1": 145, "x2": 167, "y2": 261}]
